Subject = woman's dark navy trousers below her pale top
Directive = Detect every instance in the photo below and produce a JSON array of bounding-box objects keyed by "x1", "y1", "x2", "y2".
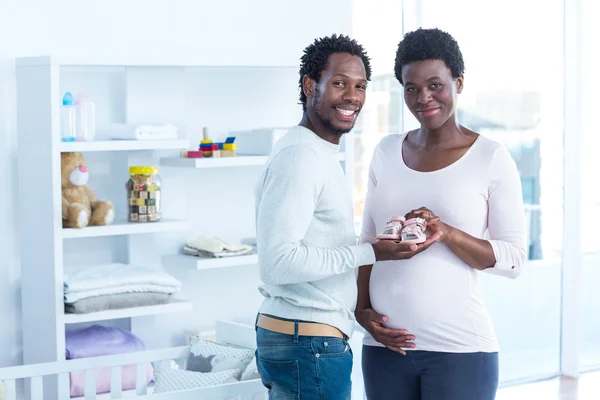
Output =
[{"x1": 362, "y1": 346, "x2": 498, "y2": 400}]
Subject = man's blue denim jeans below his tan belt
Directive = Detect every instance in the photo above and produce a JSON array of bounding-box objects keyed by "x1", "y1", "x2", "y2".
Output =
[{"x1": 256, "y1": 321, "x2": 353, "y2": 400}]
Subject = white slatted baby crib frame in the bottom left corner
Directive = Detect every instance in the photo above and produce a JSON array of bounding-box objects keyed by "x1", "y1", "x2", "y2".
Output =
[{"x1": 0, "y1": 323, "x2": 267, "y2": 400}]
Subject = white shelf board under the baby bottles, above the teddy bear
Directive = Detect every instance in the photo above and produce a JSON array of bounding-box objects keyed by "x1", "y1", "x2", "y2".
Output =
[{"x1": 60, "y1": 139, "x2": 190, "y2": 153}]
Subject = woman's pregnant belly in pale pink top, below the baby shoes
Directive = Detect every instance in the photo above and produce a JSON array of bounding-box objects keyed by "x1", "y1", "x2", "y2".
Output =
[{"x1": 370, "y1": 263, "x2": 495, "y2": 349}]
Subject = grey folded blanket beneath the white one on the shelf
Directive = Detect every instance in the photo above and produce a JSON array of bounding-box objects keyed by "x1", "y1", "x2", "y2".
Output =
[{"x1": 65, "y1": 292, "x2": 171, "y2": 314}]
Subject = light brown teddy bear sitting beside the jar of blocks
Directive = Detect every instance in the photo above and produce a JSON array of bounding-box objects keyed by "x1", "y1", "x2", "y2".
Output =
[{"x1": 60, "y1": 152, "x2": 115, "y2": 229}]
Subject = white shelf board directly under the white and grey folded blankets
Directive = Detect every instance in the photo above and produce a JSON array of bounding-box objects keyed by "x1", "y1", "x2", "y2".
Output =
[{"x1": 63, "y1": 300, "x2": 193, "y2": 324}]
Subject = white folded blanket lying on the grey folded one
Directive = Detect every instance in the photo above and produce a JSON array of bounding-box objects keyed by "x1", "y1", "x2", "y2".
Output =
[{"x1": 64, "y1": 263, "x2": 181, "y2": 303}]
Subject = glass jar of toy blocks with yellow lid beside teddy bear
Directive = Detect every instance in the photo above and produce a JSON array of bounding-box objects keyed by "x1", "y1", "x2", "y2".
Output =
[{"x1": 126, "y1": 166, "x2": 161, "y2": 222}]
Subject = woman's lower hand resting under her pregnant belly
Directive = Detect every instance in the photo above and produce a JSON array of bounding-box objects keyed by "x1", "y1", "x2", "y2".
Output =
[{"x1": 354, "y1": 308, "x2": 415, "y2": 355}]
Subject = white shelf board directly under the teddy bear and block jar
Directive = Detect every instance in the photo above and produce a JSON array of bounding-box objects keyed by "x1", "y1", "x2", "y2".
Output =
[{"x1": 62, "y1": 219, "x2": 192, "y2": 239}]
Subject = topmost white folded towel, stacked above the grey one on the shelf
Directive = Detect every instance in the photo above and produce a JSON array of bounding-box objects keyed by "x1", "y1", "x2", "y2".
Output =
[{"x1": 64, "y1": 263, "x2": 181, "y2": 293}]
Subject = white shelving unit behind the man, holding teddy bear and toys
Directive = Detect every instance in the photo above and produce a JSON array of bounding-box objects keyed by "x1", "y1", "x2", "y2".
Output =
[{"x1": 16, "y1": 57, "x2": 353, "y2": 398}]
